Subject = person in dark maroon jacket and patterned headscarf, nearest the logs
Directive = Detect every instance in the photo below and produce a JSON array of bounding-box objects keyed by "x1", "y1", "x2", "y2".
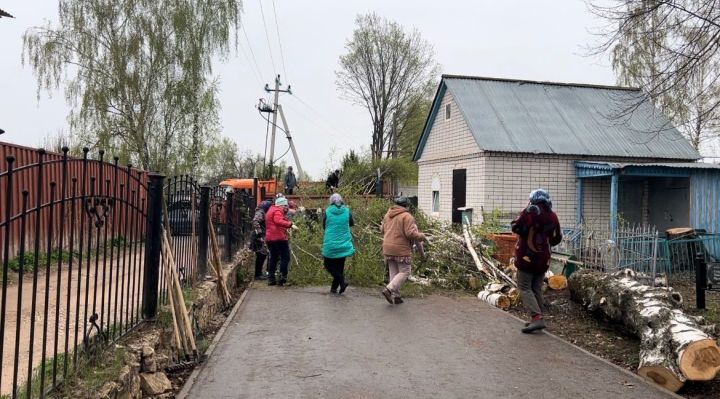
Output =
[{"x1": 512, "y1": 189, "x2": 562, "y2": 333}]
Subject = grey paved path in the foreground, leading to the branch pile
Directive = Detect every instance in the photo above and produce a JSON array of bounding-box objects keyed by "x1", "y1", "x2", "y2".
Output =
[{"x1": 183, "y1": 286, "x2": 675, "y2": 399}]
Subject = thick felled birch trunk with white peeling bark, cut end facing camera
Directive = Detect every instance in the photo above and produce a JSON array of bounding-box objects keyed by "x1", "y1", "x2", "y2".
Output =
[{"x1": 568, "y1": 270, "x2": 720, "y2": 392}]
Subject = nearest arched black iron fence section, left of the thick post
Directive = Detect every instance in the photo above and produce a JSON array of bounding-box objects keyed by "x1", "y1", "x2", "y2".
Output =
[{"x1": 0, "y1": 149, "x2": 148, "y2": 398}]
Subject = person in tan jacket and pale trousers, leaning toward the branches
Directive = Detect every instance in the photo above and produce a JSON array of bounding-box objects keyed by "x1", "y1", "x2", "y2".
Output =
[{"x1": 380, "y1": 197, "x2": 425, "y2": 305}]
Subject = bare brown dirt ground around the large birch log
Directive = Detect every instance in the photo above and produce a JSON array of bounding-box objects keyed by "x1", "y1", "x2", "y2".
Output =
[{"x1": 510, "y1": 275, "x2": 720, "y2": 399}]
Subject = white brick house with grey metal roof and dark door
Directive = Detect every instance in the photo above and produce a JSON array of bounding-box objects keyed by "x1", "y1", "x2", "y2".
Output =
[{"x1": 414, "y1": 75, "x2": 700, "y2": 231}]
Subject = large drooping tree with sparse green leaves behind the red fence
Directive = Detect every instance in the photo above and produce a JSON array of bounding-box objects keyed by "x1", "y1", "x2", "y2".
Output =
[{"x1": 23, "y1": 0, "x2": 241, "y2": 172}]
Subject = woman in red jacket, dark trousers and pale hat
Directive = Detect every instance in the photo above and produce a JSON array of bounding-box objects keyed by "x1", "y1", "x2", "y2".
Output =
[{"x1": 265, "y1": 197, "x2": 295, "y2": 286}]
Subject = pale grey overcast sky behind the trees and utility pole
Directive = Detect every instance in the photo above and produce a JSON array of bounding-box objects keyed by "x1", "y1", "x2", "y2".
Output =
[{"x1": 0, "y1": 0, "x2": 615, "y2": 179}]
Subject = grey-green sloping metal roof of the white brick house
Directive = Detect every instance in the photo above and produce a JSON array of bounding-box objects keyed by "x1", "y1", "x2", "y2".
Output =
[{"x1": 414, "y1": 75, "x2": 700, "y2": 160}]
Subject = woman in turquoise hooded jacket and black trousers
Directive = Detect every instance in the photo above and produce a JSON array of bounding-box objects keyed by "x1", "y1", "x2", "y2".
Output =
[{"x1": 322, "y1": 193, "x2": 355, "y2": 294}]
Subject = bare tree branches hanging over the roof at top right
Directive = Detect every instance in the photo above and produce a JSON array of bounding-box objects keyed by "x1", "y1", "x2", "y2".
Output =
[{"x1": 590, "y1": 0, "x2": 720, "y2": 149}]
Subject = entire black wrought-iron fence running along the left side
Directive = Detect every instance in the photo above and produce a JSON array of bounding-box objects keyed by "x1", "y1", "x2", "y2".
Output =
[{"x1": 0, "y1": 149, "x2": 251, "y2": 398}]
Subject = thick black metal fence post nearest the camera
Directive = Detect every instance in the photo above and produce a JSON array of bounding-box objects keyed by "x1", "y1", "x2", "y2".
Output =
[{"x1": 142, "y1": 173, "x2": 165, "y2": 320}]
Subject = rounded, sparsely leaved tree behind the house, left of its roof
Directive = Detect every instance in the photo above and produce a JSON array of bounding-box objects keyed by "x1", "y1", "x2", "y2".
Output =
[{"x1": 335, "y1": 13, "x2": 439, "y2": 159}]
